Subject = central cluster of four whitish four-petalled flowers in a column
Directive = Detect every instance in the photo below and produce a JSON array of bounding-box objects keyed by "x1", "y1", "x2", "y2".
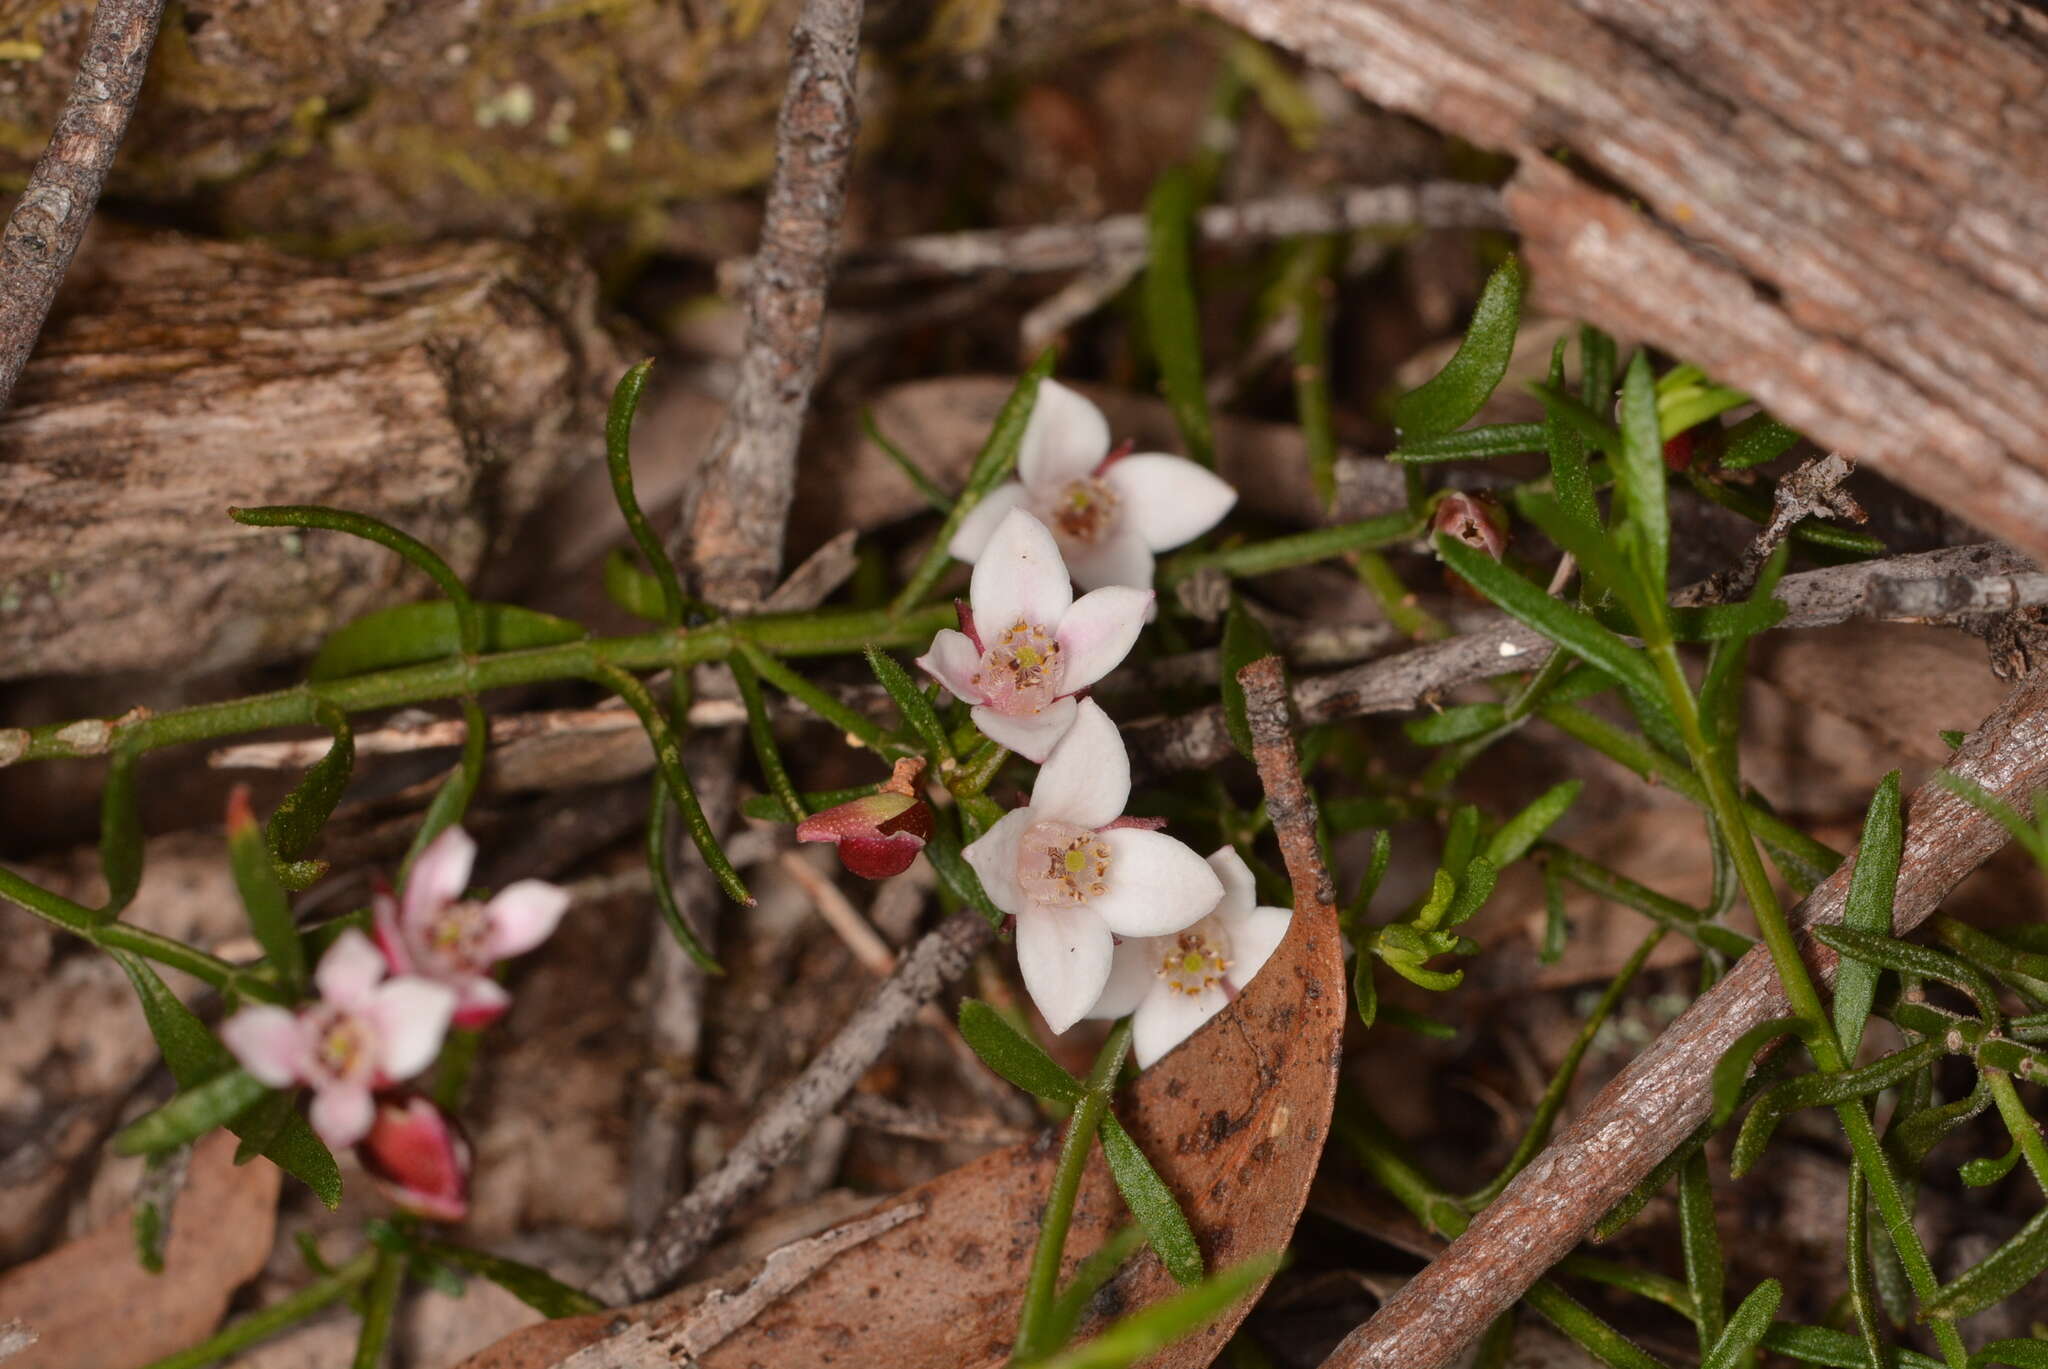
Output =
[{"x1": 937, "y1": 381, "x2": 1290, "y2": 1066}]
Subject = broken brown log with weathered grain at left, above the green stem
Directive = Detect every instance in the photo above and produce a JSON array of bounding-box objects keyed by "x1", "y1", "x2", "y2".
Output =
[{"x1": 0, "y1": 234, "x2": 621, "y2": 678}]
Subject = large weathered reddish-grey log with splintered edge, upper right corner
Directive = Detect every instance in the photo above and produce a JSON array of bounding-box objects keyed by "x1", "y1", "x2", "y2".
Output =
[{"x1": 1200, "y1": 0, "x2": 2048, "y2": 555}]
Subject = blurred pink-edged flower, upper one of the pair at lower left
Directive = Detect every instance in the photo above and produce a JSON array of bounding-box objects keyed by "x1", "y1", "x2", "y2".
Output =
[{"x1": 371, "y1": 828, "x2": 569, "y2": 1027}]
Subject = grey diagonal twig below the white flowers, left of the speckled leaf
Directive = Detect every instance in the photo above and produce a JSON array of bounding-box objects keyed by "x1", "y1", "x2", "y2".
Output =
[{"x1": 592, "y1": 912, "x2": 995, "y2": 1303}]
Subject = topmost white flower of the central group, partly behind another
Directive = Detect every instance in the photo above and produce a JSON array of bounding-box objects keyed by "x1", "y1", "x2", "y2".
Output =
[{"x1": 946, "y1": 381, "x2": 1237, "y2": 590}]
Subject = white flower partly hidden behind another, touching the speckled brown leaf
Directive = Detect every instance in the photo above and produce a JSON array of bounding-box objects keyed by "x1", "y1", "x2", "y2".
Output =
[{"x1": 1087, "y1": 846, "x2": 1294, "y2": 1070}]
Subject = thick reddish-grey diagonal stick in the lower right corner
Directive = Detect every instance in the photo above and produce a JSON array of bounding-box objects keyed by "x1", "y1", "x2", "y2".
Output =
[{"x1": 1325, "y1": 655, "x2": 2048, "y2": 1369}]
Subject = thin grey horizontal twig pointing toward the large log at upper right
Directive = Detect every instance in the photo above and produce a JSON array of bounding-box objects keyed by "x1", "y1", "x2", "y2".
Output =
[{"x1": 719, "y1": 180, "x2": 1507, "y2": 291}]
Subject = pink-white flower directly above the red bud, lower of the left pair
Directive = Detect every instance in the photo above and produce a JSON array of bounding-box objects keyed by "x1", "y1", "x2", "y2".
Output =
[{"x1": 221, "y1": 928, "x2": 455, "y2": 1150}]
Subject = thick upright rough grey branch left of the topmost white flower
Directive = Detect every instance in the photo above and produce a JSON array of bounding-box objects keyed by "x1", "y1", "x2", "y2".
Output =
[{"x1": 684, "y1": 0, "x2": 862, "y2": 609}]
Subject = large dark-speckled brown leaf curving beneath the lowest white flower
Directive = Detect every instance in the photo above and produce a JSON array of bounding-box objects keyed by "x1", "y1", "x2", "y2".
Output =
[{"x1": 461, "y1": 877, "x2": 1346, "y2": 1369}]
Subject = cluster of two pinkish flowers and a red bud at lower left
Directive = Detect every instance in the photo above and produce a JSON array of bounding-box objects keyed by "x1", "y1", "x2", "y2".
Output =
[{"x1": 221, "y1": 828, "x2": 569, "y2": 1221}]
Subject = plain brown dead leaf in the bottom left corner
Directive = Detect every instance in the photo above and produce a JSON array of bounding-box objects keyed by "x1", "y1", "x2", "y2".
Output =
[{"x1": 0, "y1": 1131, "x2": 281, "y2": 1369}]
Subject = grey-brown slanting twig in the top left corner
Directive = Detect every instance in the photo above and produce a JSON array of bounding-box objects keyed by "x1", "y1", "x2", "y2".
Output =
[{"x1": 0, "y1": 0, "x2": 164, "y2": 412}]
